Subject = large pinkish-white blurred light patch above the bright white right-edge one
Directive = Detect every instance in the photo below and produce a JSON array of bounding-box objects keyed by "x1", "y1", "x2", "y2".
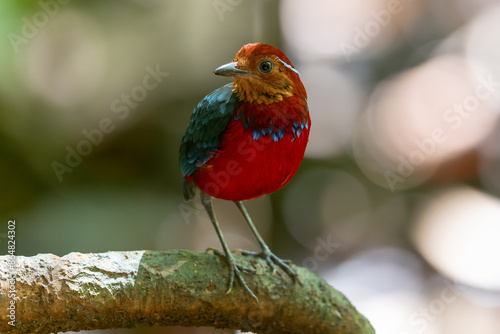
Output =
[{"x1": 354, "y1": 56, "x2": 498, "y2": 189}]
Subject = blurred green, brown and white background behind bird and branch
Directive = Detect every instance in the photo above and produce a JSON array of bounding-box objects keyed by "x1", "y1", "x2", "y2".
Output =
[{"x1": 0, "y1": 0, "x2": 500, "y2": 334}]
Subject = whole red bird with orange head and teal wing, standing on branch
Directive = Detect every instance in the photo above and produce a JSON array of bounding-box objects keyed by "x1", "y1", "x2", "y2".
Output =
[{"x1": 179, "y1": 43, "x2": 311, "y2": 300}]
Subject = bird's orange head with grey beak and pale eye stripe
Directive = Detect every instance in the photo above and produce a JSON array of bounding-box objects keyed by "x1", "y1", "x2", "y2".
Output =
[{"x1": 215, "y1": 43, "x2": 307, "y2": 104}]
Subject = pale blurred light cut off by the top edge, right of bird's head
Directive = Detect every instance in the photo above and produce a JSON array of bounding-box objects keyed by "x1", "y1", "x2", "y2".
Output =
[{"x1": 281, "y1": 0, "x2": 420, "y2": 61}]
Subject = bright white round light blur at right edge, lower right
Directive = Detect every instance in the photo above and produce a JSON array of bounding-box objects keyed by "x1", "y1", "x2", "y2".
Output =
[{"x1": 413, "y1": 188, "x2": 500, "y2": 290}]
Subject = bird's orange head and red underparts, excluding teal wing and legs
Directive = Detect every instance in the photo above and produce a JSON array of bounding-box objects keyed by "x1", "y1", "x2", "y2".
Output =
[{"x1": 181, "y1": 43, "x2": 311, "y2": 201}]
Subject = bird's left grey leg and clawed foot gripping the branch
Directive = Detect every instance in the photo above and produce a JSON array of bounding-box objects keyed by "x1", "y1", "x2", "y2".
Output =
[{"x1": 201, "y1": 193, "x2": 258, "y2": 301}]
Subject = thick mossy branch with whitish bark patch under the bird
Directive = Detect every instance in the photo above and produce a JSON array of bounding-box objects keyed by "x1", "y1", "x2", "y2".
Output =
[{"x1": 0, "y1": 250, "x2": 375, "y2": 334}]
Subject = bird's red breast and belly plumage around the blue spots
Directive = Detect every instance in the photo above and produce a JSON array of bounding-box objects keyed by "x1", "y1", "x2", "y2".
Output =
[{"x1": 189, "y1": 97, "x2": 311, "y2": 201}]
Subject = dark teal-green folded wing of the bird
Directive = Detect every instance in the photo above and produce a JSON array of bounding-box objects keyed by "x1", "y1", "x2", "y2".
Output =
[{"x1": 179, "y1": 84, "x2": 238, "y2": 188}]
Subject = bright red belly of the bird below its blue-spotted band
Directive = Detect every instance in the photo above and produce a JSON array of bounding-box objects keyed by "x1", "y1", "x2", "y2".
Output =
[{"x1": 191, "y1": 121, "x2": 309, "y2": 201}]
